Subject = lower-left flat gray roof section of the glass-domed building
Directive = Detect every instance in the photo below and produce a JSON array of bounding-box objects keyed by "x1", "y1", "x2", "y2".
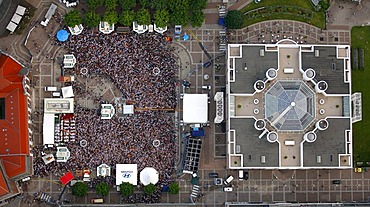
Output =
[{"x1": 230, "y1": 118, "x2": 279, "y2": 167}]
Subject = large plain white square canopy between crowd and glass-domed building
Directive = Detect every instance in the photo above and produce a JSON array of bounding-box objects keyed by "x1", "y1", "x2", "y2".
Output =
[{"x1": 183, "y1": 94, "x2": 208, "y2": 124}]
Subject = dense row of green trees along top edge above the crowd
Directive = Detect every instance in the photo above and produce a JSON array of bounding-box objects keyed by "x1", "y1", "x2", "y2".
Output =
[{"x1": 65, "y1": 0, "x2": 207, "y2": 28}]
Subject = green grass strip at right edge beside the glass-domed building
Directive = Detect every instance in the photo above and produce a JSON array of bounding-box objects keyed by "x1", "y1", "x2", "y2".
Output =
[{"x1": 351, "y1": 27, "x2": 370, "y2": 164}]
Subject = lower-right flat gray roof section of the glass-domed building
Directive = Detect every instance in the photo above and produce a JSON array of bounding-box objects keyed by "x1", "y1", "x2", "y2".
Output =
[{"x1": 303, "y1": 118, "x2": 351, "y2": 167}]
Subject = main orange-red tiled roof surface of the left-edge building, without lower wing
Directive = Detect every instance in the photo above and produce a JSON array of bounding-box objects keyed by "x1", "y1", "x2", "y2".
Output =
[{"x1": 0, "y1": 55, "x2": 29, "y2": 178}]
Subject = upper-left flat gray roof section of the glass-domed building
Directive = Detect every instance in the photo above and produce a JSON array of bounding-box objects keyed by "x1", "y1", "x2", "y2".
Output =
[{"x1": 230, "y1": 45, "x2": 278, "y2": 94}]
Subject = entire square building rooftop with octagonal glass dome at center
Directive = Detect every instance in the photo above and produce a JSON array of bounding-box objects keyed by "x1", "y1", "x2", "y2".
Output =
[{"x1": 227, "y1": 40, "x2": 352, "y2": 169}]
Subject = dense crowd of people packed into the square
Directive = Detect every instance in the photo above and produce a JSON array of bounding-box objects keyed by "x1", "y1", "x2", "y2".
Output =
[{"x1": 34, "y1": 31, "x2": 178, "y2": 201}]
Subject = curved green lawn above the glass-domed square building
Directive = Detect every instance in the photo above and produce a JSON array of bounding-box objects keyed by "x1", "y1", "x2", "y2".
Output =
[{"x1": 240, "y1": 0, "x2": 325, "y2": 29}]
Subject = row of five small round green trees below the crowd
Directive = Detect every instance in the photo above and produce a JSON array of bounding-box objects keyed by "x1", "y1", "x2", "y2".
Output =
[{"x1": 72, "y1": 182, "x2": 180, "y2": 197}]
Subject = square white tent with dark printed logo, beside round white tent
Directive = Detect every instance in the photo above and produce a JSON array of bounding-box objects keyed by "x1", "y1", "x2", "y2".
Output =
[{"x1": 116, "y1": 164, "x2": 137, "y2": 186}]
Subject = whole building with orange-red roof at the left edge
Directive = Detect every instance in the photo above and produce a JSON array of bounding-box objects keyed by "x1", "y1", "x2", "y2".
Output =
[{"x1": 0, "y1": 54, "x2": 32, "y2": 201}]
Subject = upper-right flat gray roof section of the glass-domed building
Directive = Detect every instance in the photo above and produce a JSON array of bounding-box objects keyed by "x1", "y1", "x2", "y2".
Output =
[{"x1": 302, "y1": 46, "x2": 350, "y2": 94}]
